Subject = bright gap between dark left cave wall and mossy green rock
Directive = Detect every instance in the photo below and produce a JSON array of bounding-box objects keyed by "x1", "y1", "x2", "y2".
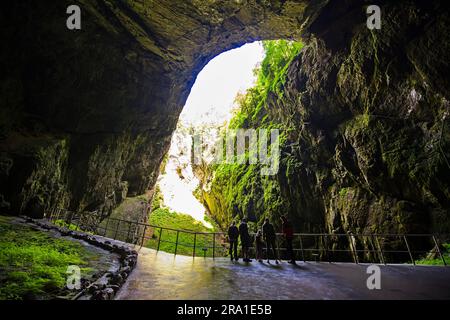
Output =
[{"x1": 150, "y1": 41, "x2": 265, "y2": 231}]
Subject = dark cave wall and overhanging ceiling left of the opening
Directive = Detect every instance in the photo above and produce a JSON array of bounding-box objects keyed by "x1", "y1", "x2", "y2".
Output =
[{"x1": 0, "y1": 0, "x2": 323, "y2": 216}]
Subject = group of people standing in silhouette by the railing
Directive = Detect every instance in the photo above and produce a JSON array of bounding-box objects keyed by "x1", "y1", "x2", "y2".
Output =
[{"x1": 228, "y1": 216, "x2": 295, "y2": 264}]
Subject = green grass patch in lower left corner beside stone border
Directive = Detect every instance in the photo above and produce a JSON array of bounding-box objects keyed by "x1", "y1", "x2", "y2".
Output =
[{"x1": 0, "y1": 216, "x2": 92, "y2": 300}]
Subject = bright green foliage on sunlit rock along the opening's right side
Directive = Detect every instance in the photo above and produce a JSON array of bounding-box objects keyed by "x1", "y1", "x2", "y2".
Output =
[{"x1": 207, "y1": 40, "x2": 303, "y2": 227}]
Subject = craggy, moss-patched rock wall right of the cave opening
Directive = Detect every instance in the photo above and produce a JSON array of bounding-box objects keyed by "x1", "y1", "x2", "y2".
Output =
[{"x1": 193, "y1": 3, "x2": 450, "y2": 233}]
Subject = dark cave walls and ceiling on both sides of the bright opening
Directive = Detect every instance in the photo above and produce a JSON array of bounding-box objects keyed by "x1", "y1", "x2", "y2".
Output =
[{"x1": 0, "y1": 0, "x2": 450, "y2": 235}]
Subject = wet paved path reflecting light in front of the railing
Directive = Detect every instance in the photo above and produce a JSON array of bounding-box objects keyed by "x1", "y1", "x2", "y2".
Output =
[{"x1": 116, "y1": 248, "x2": 450, "y2": 300}]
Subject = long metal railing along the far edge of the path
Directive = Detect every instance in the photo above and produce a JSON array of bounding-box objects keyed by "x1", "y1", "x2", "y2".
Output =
[{"x1": 45, "y1": 210, "x2": 450, "y2": 265}]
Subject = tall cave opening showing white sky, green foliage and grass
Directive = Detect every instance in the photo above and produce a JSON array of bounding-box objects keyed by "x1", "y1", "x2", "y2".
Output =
[{"x1": 141, "y1": 39, "x2": 303, "y2": 255}]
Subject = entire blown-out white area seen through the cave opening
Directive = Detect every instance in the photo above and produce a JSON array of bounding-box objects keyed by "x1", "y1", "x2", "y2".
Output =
[{"x1": 159, "y1": 42, "x2": 264, "y2": 228}]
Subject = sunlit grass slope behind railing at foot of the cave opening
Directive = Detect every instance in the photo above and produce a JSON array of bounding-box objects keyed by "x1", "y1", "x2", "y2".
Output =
[{"x1": 146, "y1": 207, "x2": 223, "y2": 257}]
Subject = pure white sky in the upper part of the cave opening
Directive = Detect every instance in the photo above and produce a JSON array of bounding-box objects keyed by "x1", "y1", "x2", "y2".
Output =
[{"x1": 180, "y1": 42, "x2": 264, "y2": 126}]
